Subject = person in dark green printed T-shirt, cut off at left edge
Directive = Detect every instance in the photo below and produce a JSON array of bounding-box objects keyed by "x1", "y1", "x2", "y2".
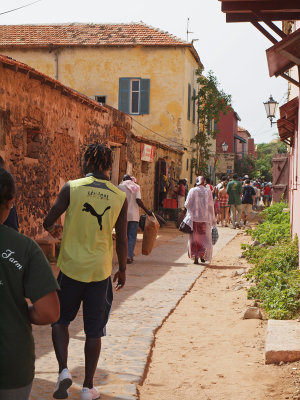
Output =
[{"x1": 0, "y1": 168, "x2": 59, "y2": 400}]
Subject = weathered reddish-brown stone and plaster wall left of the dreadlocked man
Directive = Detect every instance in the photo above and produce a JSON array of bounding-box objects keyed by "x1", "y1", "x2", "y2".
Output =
[{"x1": 0, "y1": 59, "x2": 131, "y2": 238}]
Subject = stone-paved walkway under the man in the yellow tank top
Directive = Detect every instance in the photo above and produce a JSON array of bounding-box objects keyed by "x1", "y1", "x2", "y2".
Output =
[{"x1": 31, "y1": 228, "x2": 237, "y2": 400}]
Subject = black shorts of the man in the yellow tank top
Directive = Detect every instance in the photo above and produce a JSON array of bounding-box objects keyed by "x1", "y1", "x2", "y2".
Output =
[{"x1": 53, "y1": 272, "x2": 113, "y2": 338}]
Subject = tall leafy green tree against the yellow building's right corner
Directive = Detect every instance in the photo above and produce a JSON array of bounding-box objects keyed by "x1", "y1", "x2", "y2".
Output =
[{"x1": 191, "y1": 68, "x2": 232, "y2": 175}]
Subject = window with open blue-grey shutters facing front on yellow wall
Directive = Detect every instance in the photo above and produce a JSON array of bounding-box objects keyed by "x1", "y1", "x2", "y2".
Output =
[{"x1": 119, "y1": 78, "x2": 150, "y2": 115}]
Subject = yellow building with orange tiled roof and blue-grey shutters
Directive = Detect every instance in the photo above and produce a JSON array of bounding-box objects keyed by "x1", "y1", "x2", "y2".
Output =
[{"x1": 0, "y1": 23, "x2": 203, "y2": 187}]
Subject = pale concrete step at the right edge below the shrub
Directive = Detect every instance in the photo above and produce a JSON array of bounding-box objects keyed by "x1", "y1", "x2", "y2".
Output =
[{"x1": 265, "y1": 319, "x2": 300, "y2": 364}]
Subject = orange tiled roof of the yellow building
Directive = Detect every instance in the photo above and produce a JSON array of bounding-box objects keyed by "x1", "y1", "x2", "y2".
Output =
[{"x1": 0, "y1": 23, "x2": 202, "y2": 65}]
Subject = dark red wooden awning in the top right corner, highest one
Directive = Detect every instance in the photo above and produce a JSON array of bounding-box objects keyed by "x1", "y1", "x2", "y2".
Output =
[{"x1": 219, "y1": 0, "x2": 300, "y2": 22}]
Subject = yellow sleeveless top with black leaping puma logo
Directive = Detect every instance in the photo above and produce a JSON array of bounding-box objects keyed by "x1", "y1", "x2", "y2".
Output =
[{"x1": 57, "y1": 176, "x2": 126, "y2": 282}]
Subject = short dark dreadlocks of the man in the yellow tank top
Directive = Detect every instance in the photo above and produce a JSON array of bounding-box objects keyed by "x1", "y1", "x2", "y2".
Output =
[{"x1": 83, "y1": 143, "x2": 112, "y2": 174}]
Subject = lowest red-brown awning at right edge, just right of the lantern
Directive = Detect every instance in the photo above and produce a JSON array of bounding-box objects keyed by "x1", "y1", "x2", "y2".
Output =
[{"x1": 277, "y1": 97, "x2": 299, "y2": 146}]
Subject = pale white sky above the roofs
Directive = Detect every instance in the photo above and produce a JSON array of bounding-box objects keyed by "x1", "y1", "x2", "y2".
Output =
[{"x1": 0, "y1": 0, "x2": 287, "y2": 143}]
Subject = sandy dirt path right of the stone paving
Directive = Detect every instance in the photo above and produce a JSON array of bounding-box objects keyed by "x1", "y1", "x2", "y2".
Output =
[{"x1": 139, "y1": 231, "x2": 300, "y2": 400}]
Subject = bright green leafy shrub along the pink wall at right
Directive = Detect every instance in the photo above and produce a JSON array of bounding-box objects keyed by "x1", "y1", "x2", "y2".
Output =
[{"x1": 242, "y1": 203, "x2": 300, "y2": 319}]
